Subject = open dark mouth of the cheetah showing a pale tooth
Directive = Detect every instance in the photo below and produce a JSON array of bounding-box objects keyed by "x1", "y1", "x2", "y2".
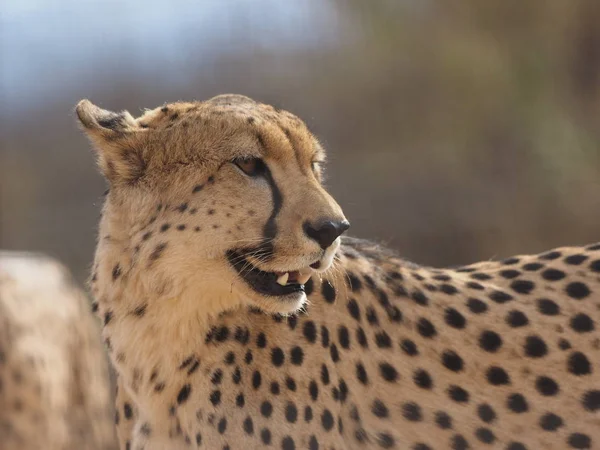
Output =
[{"x1": 227, "y1": 250, "x2": 312, "y2": 297}]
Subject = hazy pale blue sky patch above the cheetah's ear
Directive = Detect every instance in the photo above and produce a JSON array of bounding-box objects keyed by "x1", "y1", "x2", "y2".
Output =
[{"x1": 0, "y1": 0, "x2": 337, "y2": 112}]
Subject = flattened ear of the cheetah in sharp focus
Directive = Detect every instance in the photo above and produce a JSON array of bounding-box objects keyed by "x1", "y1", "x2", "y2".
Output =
[{"x1": 75, "y1": 100, "x2": 146, "y2": 184}]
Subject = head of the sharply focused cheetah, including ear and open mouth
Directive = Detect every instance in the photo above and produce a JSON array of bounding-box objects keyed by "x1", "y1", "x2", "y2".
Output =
[{"x1": 76, "y1": 95, "x2": 350, "y2": 313}]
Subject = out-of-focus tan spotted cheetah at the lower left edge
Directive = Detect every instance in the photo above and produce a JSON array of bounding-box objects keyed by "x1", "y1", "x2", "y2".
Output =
[{"x1": 0, "y1": 252, "x2": 117, "y2": 450}]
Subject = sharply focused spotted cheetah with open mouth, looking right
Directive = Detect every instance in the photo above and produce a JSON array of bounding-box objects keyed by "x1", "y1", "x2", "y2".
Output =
[{"x1": 76, "y1": 95, "x2": 600, "y2": 450}]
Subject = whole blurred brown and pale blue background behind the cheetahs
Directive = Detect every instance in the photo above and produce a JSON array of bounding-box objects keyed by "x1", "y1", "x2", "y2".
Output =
[{"x1": 0, "y1": 0, "x2": 600, "y2": 281}]
